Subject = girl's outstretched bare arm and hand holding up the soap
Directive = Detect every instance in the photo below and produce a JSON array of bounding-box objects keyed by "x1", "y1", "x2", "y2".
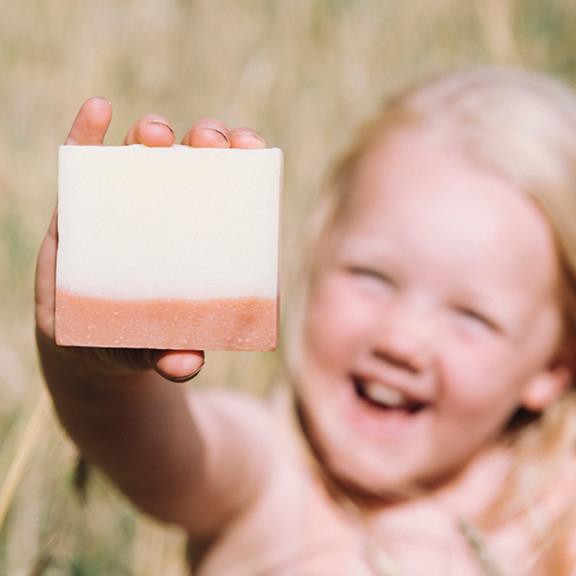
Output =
[{"x1": 36, "y1": 98, "x2": 274, "y2": 534}]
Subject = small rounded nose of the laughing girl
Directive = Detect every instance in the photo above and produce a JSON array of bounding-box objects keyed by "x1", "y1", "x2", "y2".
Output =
[{"x1": 374, "y1": 304, "x2": 434, "y2": 374}]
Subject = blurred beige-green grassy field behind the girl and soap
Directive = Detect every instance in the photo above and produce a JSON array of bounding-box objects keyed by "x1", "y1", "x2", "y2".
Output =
[{"x1": 0, "y1": 0, "x2": 576, "y2": 576}]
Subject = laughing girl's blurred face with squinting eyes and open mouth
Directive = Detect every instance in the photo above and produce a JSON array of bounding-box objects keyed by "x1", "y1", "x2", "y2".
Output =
[{"x1": 299, "y1": 130, "x2": 568, "y2": 492}]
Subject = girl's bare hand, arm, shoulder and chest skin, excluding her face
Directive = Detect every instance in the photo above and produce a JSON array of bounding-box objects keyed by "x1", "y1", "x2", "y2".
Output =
[{"x1": 36, "y1": 98, "x2": 572, "y2": 576}]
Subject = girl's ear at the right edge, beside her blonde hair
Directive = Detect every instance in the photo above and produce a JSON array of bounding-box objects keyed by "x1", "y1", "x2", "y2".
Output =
[{"x1": 522, "y1": 342, "x2": 576, "y2": 412}]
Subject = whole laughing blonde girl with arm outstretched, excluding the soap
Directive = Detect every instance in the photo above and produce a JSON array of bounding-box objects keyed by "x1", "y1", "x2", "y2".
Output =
[{"x1": 36, "y1": 69, "x2": 576, "y2": 576}]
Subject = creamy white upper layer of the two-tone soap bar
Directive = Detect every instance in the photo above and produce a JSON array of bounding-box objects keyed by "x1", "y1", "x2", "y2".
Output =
[{"x1": 57, "y1": 145, "x2": 282, "y2": 299}]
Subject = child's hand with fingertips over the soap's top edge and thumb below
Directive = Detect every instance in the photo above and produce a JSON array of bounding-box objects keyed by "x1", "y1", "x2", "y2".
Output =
[{"x1": 36, "y1": 98, "x2": 266, "y2": 381}]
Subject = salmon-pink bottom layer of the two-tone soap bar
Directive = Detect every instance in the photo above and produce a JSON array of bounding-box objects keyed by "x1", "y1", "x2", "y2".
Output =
[{"x1": 56, "y1": 290, "x2": 278, "y2": 350}]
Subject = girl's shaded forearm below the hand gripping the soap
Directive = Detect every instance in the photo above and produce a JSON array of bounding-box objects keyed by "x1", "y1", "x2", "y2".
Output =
[{"x1": 38, "y1": 334, "x2": 203, "y2": 524}]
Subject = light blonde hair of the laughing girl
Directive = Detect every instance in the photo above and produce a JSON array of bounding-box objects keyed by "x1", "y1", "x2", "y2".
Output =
[{"x1": 288, "y1": 67, "x2": 576, "y2": 576}]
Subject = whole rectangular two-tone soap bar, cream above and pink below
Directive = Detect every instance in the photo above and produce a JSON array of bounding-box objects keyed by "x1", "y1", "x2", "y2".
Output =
[{"x1": 55, "y1": 145, "x2": 282, "y2": 350}]
